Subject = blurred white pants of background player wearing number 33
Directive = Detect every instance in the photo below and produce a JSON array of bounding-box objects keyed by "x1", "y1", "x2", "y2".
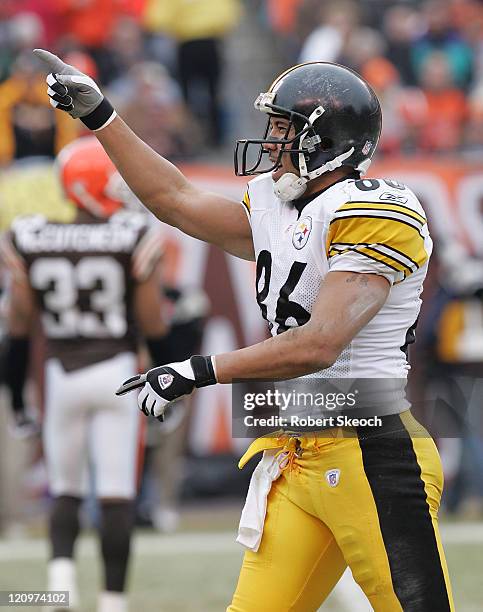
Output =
[{"x1": 43, "y1": 353, "x2": 140, "y2": 499}]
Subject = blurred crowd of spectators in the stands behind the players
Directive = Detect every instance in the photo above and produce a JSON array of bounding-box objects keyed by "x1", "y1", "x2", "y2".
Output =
[{"x1": 0, "y1": 0, "x2": 483, "y2": 164}]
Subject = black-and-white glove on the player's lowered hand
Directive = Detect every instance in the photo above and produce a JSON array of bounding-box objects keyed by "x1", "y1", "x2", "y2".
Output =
[{"x1": 116, "y1": 355, "x2": 217, "y2": 421}]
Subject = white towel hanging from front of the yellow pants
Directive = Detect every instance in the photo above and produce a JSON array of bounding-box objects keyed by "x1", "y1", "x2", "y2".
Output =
[{"x1": 236, "y1": 449, "x2": 287, "y2": 552}]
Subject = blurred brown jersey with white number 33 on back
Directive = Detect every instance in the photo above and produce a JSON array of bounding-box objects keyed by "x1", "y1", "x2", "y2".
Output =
[{"x1": 6, "y1": 211, "x2": 161, "y2": 371}]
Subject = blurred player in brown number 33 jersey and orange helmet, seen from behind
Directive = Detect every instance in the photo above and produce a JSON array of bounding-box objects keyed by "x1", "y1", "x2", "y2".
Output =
[{"x1": 2, "y1": 136, "x2": 164, "y2": 612}]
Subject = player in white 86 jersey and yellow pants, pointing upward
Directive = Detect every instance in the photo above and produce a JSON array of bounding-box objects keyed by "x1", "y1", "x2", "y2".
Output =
[{"x1": 36, "y1": 50, "x2": 454, "y2": 612}]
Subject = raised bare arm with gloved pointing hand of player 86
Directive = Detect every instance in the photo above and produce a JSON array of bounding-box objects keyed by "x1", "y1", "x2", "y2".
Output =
[{"x1": 34, "y1": 49, "x2": 254, "y2": 260}]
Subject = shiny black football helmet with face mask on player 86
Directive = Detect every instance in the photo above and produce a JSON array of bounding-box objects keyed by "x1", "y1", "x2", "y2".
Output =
[{"x1": 235, "y1": 62, "x2": 382, "y2": 194}]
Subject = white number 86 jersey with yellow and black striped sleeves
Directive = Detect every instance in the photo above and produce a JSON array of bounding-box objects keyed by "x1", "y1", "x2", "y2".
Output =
[{"x1": 243, "y1": 174, "x2": 432, "y2": 378}]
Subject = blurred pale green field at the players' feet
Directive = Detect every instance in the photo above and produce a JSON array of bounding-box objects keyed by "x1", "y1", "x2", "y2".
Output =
[{"x1": 0, "y1": 523, "x2": 483, "y2": 612}]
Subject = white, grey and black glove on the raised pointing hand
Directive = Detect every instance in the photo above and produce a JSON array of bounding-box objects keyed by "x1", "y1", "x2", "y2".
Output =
[{"x1": 33, "y1": 49, "x2": 117, "y2": 131}]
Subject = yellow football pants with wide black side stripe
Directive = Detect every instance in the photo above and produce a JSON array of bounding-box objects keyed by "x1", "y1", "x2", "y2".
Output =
[{"x1": 227, "y1": 411, "x2": 454, "y2": 612}]
